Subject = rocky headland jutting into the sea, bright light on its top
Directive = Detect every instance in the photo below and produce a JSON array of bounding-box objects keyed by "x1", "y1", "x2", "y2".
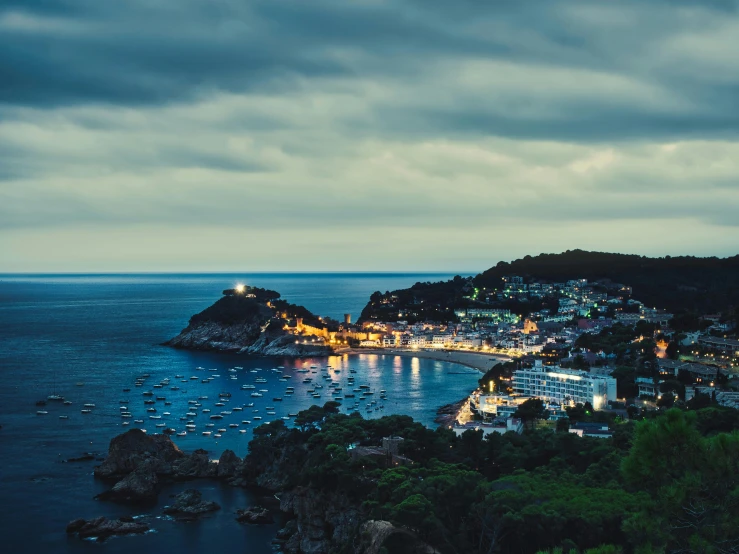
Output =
[{"x1": 165, "y1": 287, "x2": 331, "y2": 356}]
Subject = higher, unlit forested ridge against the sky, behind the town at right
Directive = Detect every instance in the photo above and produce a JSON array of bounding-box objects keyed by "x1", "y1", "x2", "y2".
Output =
[{"x1": 475, "y1": 250, "x2": 739, "y2": 312}]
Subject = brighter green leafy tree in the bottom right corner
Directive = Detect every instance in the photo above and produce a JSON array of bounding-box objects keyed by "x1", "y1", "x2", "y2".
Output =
[{"x1": 621, "y1": 409, "x2": 739, "y2": 553}]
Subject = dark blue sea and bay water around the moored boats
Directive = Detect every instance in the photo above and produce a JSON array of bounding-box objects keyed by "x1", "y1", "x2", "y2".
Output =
[{"x1": 0, "y1": 274, "x2": 479, "y2": 554}]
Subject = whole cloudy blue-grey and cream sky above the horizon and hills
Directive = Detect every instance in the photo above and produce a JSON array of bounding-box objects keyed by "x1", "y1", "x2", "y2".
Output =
[{"x1": 0, "y1": 0, "x2": 739, "y2": 272}]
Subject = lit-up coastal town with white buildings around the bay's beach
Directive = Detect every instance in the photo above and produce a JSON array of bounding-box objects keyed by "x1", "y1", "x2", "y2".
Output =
[{"x1": 274, "y1": 275, "x2": 739, "y2": 438}]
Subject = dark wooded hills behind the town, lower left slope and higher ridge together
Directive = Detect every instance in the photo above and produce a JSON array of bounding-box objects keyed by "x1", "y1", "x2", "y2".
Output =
[{"x1": 361, "y1": 250, "x2": 739, "y2": 321}]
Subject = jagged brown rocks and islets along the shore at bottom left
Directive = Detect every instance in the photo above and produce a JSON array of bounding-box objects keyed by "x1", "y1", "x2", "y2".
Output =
[{"x1": 76, "y1": 429, "x2": 433, "y2": 554}]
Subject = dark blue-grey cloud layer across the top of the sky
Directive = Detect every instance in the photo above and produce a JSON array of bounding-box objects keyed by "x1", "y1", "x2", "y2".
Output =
[{"x1": 0, "y1": 0, "x2": 739, "y2": 140}]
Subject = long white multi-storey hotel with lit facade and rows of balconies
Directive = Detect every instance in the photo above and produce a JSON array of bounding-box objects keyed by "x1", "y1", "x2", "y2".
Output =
[{"x1": 512, "y1": 360, "x2": 616, "y2": 410}]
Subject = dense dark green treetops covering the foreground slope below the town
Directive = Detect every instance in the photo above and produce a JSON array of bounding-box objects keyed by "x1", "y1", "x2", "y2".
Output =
[{"x1": 247, "y1": 403, "x2": 739, "y2": 554}]
